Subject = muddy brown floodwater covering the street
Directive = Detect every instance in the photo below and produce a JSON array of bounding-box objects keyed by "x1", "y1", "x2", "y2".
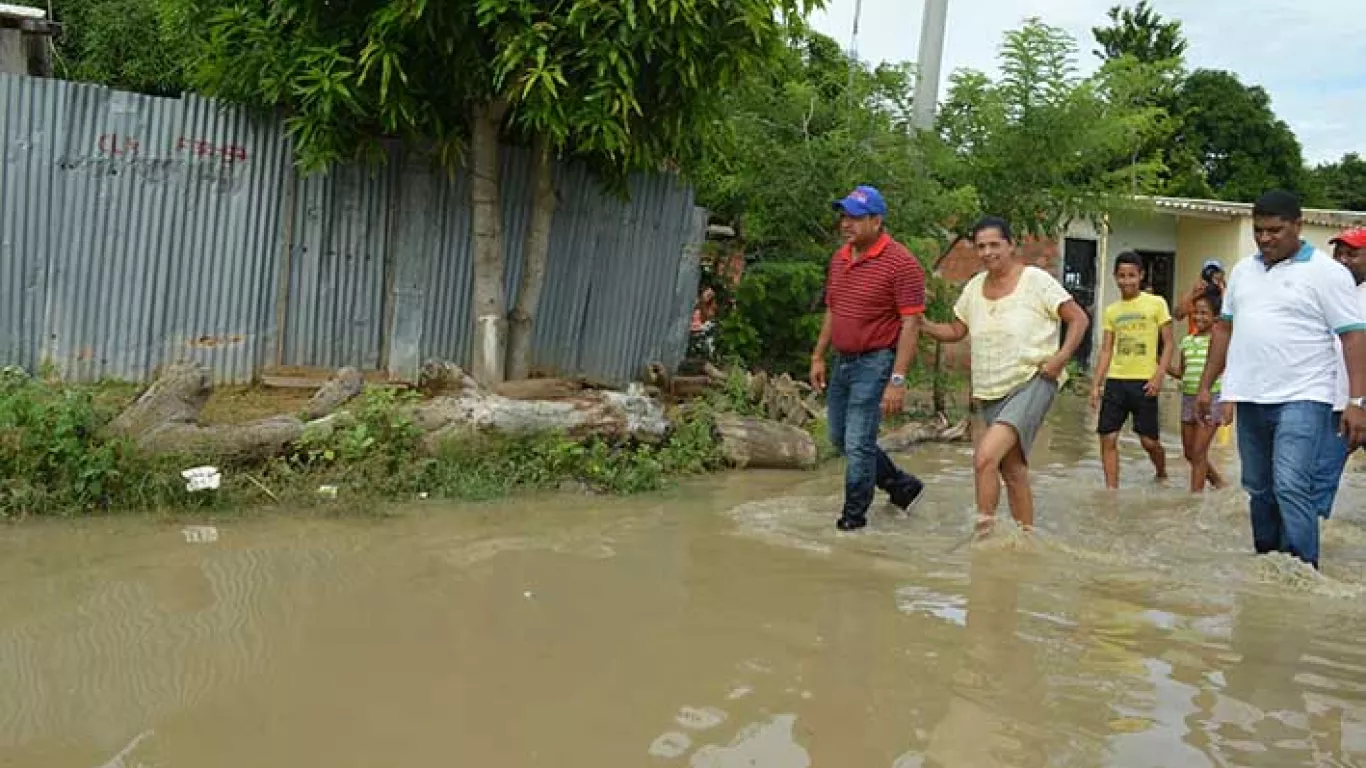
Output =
[{"x1": 0, "y1": 399, "x2": 1366, "y2": 768}]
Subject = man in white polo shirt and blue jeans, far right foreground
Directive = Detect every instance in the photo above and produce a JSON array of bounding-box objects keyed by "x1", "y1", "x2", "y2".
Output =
[{"x1": 1195, "y1": 190, "x2": 1366, "y2": 568}]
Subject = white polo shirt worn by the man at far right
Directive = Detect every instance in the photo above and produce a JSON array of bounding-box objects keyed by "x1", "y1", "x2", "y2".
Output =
[{"x1": 1220, "y1": 243, "x2": 1366, "y2": 404}]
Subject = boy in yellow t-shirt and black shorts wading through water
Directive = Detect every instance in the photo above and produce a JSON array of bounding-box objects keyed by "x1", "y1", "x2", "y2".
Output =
[{"x1": 1091, "y1": 251, "x2": 1175, "y2": 488}]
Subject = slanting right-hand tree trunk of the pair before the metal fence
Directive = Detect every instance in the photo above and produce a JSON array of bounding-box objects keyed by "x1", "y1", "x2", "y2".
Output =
[{"x1": 507, "y1": 137, "x2": 557, "y2": 380}]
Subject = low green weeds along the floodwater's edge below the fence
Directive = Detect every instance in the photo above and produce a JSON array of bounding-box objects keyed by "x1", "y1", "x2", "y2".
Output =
[{"x1": 0, "y1": 372, "x2": 728, "y2": 518}]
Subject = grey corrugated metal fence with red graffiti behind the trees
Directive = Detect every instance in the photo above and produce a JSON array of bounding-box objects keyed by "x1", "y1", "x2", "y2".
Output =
[{"x1": 0, "y1": 75, "x2": 705, "y2": 383}]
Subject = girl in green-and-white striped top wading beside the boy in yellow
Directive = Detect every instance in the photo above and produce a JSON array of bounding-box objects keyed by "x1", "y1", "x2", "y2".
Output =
[{"x1": 1167, "y1": 290, "x2": 1232, "y2": 493}]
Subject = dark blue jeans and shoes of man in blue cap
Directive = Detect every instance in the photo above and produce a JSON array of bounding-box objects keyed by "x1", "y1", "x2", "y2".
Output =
[{"x1": 825, "y1": 350, "x2": 921, "y2": 518}]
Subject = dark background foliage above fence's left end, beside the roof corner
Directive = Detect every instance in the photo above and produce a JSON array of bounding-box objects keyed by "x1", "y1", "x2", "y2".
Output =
[{"x1": 52, "y1": 0, "x2": 190, "y2": 96}]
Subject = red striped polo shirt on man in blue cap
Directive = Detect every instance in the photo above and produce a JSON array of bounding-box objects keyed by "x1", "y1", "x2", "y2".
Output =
[{"x1": 825, "y1": 232, "x2": 925, "y2": 355}]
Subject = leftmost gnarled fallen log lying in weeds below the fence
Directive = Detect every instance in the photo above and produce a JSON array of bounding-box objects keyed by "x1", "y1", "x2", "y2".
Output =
[{"x1": 105, "y1": 364, "x2": 359, "y2": 461}]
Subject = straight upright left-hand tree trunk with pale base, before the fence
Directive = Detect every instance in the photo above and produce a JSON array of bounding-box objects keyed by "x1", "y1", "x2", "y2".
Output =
[{"x1": 470, "y1": 101, "x2": 507, "y2": 387}]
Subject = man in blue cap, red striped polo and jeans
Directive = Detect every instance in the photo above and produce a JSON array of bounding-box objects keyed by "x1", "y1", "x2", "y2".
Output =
[{"x1": 811, "y1": 186, "x2": 925, "y2": 530}]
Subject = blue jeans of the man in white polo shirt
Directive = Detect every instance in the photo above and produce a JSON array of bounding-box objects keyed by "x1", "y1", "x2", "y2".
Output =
[{"x1": 1238, "y1": 400, "x2": 1336, "y2": 567}]
